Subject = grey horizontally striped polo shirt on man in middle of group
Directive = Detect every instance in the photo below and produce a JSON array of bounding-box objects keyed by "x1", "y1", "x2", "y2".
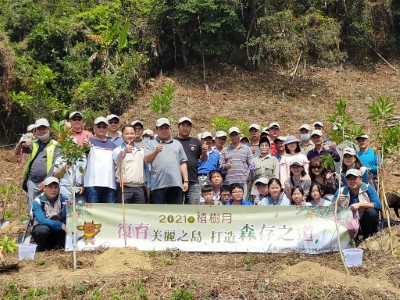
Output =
[{"x1": 219, "y1": 144, "x2": 253, "y2": 184}]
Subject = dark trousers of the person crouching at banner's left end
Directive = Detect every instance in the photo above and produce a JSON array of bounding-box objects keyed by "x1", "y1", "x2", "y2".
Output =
[{"x1": 32, "y1": 224, "x2": 65, "y2": 252}]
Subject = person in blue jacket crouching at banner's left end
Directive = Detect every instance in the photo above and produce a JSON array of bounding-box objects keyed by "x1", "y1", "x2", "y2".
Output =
[{"x1": 32, "y1": 177, "x2": 67, "y2": 251}]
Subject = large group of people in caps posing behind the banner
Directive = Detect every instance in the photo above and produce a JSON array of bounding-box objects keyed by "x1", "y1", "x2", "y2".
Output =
[{"x1": 17, "y1": 111, "x2": 381, "y2": 251}]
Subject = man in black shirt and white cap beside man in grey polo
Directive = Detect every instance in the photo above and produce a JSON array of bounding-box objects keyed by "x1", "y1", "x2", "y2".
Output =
[{"x1": 174, "y1": 117, "x2": 208, "y2": 204}]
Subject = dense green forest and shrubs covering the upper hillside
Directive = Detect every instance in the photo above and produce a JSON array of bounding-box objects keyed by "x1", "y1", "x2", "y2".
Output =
[{"x1": 0, "y1": 0, "x2": 400, "y2": 141}]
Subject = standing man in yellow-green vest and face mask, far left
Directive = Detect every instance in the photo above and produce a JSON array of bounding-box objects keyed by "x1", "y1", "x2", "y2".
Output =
[{"x1": 22, "y1": 119, "x2": 60, "y2": 213}]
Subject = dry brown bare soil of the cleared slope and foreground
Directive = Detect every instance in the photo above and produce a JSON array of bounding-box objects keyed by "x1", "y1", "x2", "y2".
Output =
[{"x1": 0, "y1": 63, "x2": 400, "y2": 299}]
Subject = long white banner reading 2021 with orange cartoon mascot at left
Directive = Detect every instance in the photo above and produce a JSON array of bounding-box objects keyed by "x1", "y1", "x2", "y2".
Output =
[{"x1": 66, "y1": 204, "x2": 357, "y2": 254}]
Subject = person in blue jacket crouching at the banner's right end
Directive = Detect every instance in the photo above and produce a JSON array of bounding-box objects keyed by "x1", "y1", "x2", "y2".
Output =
[{"x1": 332, "y1": 169, "x2": 382, "y2": 239}]
